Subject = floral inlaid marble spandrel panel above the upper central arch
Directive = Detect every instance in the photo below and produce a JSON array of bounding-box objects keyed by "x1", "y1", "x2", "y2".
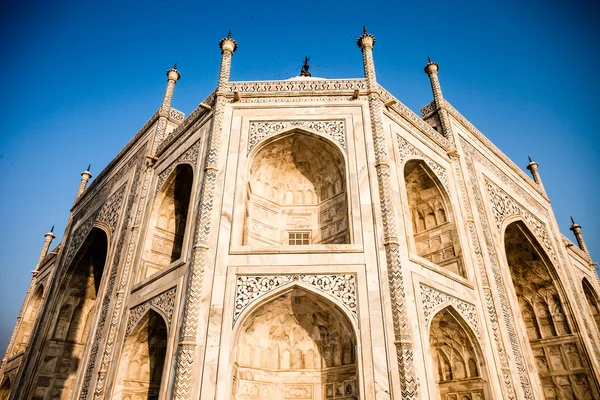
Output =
[{"x1": 248, "y1": 120, "x2": 346, "y2": 152}]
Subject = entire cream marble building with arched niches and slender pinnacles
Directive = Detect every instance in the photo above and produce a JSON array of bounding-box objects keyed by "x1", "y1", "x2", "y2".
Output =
[{"x1": 0, "y1": 29, "x2": 600, "y2": 400}]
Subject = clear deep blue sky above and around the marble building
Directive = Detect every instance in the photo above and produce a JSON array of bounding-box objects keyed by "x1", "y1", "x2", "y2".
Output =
[{"x1": 0, "y1": 0, "x2": 600, "y2": 354}]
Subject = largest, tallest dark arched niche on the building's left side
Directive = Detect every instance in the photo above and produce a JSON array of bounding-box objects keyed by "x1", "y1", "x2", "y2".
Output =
[{"x1": 33, "y1": 228, "x2": 108, "y2": 399}]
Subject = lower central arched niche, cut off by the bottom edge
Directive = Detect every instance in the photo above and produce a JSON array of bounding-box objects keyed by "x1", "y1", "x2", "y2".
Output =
[{"x1": 231, "y1": 287, "x2": 359, "y2": 400}]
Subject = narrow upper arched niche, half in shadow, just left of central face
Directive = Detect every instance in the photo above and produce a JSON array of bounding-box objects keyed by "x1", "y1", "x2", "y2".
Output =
[{"x1": 140, "y1": 164, "x2": 194, "y2": 280}]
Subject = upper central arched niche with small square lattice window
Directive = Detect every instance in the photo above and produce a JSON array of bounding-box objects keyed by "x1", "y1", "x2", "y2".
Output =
[{"x1": 243, "y1": 131, "x2": 351, "y2": 246}]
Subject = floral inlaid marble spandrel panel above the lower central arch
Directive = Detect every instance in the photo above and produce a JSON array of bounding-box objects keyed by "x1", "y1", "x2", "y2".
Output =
[{"x1": 233, "y1": 274, "x2": 357, "y2": 325}]
